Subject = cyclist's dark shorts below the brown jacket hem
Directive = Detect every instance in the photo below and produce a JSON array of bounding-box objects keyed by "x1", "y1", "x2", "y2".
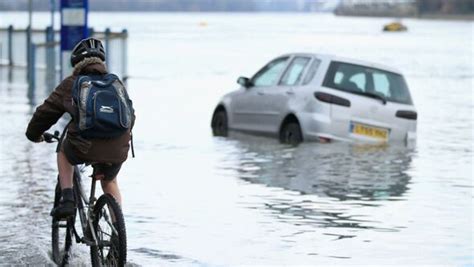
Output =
[{"x1": 61, "y1": 140, "x2": 122, "y2": 181}]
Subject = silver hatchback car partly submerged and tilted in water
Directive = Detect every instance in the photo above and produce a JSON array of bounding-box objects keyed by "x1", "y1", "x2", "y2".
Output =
[{"x1": 211, "y1": 53, "x2": 417, "y2": 144}]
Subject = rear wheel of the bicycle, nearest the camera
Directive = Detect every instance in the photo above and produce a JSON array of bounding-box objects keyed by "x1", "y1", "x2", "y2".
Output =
[{"x1": 91, "y1": 194, "x2": 127, "y2": 266}]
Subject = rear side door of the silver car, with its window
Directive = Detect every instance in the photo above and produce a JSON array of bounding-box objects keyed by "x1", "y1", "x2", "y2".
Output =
[{"x1": 261, "y1": 56, "x2": 311, "y2": 133}]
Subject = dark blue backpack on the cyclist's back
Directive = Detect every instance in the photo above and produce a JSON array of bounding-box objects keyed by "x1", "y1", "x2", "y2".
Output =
[{"x1": 72, "y1": 74, "x2": 133, "y2": 139}]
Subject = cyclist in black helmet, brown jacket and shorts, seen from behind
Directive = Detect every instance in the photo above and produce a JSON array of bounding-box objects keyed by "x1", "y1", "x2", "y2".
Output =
[{"x1": 26, "y1": 38, "x2": 135, "y2": 222}]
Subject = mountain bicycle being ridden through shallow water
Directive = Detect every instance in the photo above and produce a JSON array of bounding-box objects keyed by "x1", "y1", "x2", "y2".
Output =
[{"x1": 43, "y1": 131, "x2": 127, "y2": 266}]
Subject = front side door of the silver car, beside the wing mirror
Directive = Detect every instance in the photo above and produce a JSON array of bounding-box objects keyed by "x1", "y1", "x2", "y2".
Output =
[{"x1": 232, "y1": 57, "x2": 289, "y2": 132}]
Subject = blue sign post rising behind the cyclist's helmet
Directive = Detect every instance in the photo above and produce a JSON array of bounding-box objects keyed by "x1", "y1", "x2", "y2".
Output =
[{"x1": 61, "y1": 0, "x2": 89, "y2": 79}]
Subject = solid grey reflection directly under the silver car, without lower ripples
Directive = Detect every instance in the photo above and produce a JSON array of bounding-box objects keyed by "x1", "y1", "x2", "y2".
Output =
[{"x1": 229, "y1": 133, "x2": 413, "y2": 201}]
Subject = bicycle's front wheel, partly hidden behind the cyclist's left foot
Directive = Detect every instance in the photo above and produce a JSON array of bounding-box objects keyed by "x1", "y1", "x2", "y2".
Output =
[{"x1": 51, "y1": 183, "x2": 75, "y2": 266}]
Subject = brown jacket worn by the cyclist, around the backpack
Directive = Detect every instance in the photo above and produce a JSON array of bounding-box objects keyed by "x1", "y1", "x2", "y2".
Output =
[{"x1": 26, "y1": 64, "x2": 135, "y2": 163}]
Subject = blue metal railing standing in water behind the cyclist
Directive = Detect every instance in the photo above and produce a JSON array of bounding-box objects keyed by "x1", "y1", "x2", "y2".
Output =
[{"x1": 0, "y1": 26, "x2": 128, "y2": 90}]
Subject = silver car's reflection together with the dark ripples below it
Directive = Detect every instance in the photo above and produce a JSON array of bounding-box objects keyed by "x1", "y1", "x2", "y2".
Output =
[{"x1": 223, "y1": 132, "x2": 414, "y2": 236}]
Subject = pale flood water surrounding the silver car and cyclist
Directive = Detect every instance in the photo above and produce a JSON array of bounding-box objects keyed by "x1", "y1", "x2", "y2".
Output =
[{"x1": 0, "y1": 13, "x2": 474, "y2": 266}]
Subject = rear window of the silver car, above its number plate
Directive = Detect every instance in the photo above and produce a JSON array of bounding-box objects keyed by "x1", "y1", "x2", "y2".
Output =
[{"x1": 323, "y1": 61, "x2": 413, "y2": 105}]
